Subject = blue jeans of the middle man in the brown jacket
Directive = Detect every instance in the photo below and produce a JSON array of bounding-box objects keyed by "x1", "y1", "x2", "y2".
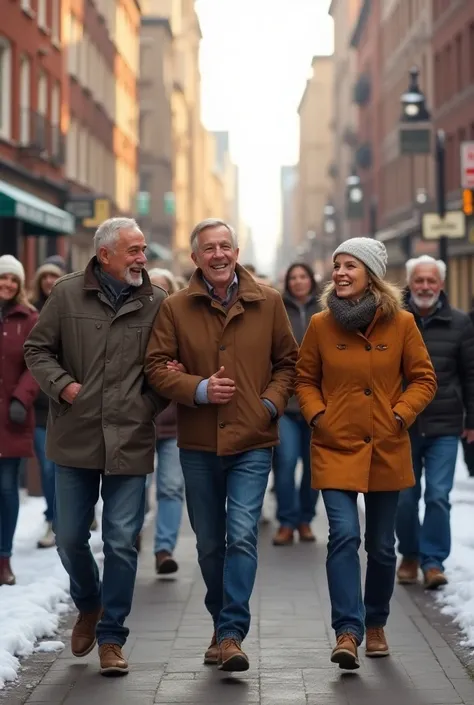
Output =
[{"x1": 180, "y1": 448, "x2": 272, "y2": 641}]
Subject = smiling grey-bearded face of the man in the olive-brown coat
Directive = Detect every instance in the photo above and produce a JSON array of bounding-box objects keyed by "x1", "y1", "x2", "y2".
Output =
[{"x1": 97, "y1": 228, "x2": 147, "y2": 286}]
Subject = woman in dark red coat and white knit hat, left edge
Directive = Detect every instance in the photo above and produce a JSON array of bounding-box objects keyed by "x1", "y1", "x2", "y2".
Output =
[{"x1": 0, "y1": 255, "x2": 39, "y2": 585}]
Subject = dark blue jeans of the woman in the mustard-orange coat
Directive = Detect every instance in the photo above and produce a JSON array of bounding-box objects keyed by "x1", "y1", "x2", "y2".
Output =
[{"x1": 322, "y1": 490, "x2": 399, "y2": 643}]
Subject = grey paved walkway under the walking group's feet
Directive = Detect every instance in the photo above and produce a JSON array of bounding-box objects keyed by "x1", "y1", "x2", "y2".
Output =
[{"x1": 0, "y1": 500, "x2": 474, "y2": 705}]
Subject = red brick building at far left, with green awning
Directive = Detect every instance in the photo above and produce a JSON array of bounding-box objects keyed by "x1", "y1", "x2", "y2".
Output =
[{"x1": 0, "y1": 0, "x2": 74, "y2": 279}]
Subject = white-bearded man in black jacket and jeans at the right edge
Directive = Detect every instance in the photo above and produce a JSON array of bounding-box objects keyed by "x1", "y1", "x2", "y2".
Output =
[{"x1": 397, "y1": 255, "x2": 474, "y2": 590}]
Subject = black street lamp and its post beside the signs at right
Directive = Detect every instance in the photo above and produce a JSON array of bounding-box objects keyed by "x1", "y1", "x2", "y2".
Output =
[{"x1": 400, "y1": 67, "x2": 448, "y2": 276}]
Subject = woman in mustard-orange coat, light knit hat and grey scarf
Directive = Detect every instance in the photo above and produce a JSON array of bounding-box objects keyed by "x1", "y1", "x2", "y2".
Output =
[{"x1": 296, "y1": 238, "x2": 436, "y2": 670}]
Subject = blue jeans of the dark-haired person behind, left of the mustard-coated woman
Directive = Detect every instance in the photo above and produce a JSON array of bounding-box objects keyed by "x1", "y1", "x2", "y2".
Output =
[{"x1": 273, "y1": 414, "x2": 318, "y2": 529}]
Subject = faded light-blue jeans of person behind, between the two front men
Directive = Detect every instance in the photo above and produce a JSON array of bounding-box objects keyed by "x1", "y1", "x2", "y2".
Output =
[{"x1": 155, "y1": 438, "x2": 184, "y2": 553}]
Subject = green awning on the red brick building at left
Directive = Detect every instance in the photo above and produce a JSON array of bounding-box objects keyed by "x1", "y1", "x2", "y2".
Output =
[{"x1": 0, "y1": 181, "x2": 75, "y2": 235}]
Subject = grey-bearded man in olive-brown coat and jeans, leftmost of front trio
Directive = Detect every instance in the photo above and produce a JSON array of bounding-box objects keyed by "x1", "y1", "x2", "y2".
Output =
[{"x1": 25, "y1": 218, "x2": 166, "y2": 674}]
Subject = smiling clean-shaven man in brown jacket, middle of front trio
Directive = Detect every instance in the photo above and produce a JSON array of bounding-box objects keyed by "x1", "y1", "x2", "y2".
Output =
[{"x1": 145, "y1": 219, "x2": 297, "y2": 671}]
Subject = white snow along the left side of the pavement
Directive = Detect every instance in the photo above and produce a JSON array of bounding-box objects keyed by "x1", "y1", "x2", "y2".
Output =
[{"x1": 0, "y1": 496, "x2": 103, "y2": 689}]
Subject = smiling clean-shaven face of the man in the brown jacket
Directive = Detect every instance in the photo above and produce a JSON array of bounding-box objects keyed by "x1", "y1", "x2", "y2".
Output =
[{"x1": 191, "y1": 225, "x2": 239, "y2": 291}]
